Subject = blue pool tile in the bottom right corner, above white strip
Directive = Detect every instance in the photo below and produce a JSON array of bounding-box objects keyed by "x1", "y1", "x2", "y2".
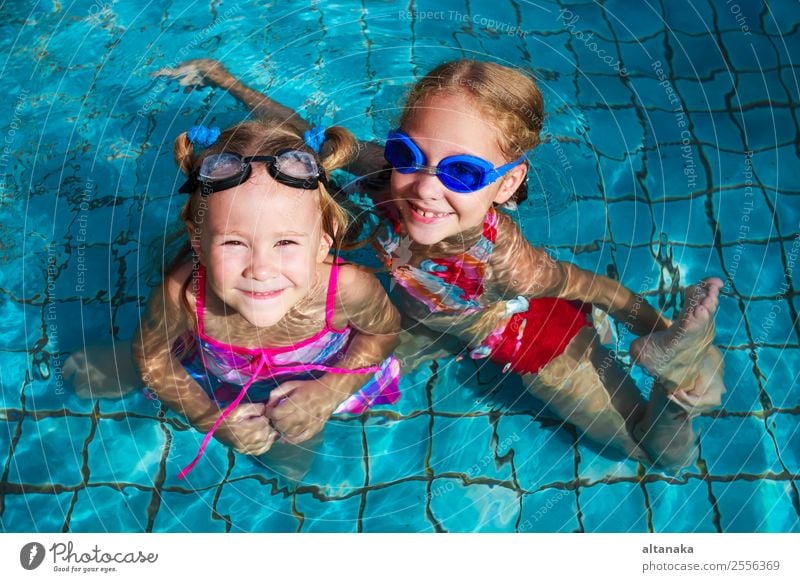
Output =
[{"x1": 712, "y1": 480, "x2": 800, "y2": 533}]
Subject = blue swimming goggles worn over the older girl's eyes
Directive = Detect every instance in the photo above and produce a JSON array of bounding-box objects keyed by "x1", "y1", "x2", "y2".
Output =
[{"x1": 383, "y1": 130, "x2": 525, "y2": 194}]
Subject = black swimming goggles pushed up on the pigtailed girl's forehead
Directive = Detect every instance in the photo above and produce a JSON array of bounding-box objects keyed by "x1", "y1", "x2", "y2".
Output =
[{"x1": 178, "y1": 150, "x2": 327, "y2": 195}]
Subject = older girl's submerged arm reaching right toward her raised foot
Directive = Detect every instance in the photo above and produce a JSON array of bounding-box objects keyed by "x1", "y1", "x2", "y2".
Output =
[{"x1": 491, "y1": 213, "x2": 670, "y2": 335}]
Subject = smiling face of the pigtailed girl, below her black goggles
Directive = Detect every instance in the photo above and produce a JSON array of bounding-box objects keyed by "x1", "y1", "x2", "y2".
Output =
[{"x1": 187, "y1": 164, "x2": 331, "y2": 327}]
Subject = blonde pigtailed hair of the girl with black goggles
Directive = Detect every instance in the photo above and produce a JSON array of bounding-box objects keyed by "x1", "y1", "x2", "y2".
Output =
[{"x1": 165, "y1": 120, "x2": 358, "y2": 312}]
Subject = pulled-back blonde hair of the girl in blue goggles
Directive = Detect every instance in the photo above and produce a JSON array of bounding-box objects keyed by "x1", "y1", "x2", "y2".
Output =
[{"x1": 400, "y1": 59, "x2": 544, "y2": 203}]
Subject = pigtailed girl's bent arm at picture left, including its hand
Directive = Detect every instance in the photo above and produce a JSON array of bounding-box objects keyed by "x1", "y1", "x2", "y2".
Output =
[{"x1": 133, "y1": 265, "x2": 277, "y2": 455}]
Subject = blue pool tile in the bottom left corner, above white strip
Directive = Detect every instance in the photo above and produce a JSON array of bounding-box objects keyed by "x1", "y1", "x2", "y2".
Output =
[{"x1": 0, "y1": 493, "x2": 72, "y2": 533}]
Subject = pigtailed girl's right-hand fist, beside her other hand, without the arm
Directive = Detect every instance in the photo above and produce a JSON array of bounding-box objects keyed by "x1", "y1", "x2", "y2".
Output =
[{"x1": 267, "y1": 380, "x2": 343, "y2": 444}]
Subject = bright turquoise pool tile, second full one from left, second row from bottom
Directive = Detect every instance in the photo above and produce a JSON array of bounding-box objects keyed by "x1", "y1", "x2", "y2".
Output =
[{"x1": 88, "y1": 418, "x2": 166, "y2": 486}]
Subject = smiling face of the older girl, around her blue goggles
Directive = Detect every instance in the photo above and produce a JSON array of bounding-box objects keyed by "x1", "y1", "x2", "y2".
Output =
[{"x1": 391, "y1": 93, "x2": 527, "y2": 245}]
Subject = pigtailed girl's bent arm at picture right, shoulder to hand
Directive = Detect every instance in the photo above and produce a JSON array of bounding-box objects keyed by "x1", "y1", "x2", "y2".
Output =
[{"x1": 268, "y1": 265, "x2": 400, "y2": 443}]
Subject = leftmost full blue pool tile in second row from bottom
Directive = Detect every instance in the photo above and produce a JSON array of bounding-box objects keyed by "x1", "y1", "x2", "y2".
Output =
[{"x1": 8, "y1": 416, "x2": 90, "y2": 486}]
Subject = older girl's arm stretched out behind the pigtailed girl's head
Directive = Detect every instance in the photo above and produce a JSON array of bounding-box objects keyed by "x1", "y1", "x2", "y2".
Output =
[{"x1": 152, "y1": 59, "x2": 386, "y2": 182}]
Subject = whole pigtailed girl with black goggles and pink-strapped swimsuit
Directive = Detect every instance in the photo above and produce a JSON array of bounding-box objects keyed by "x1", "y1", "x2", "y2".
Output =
[{"x1": 134, "y1": 121, "x2": 399, "y2": 477}]
